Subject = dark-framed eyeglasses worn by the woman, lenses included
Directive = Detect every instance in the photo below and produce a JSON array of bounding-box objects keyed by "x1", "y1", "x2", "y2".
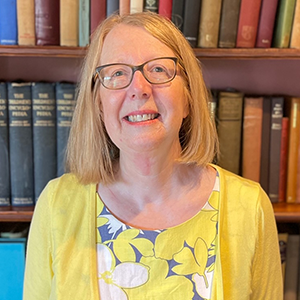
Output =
[{"x1": 92, "y1": 57, "x2": 177, "y2": 90}]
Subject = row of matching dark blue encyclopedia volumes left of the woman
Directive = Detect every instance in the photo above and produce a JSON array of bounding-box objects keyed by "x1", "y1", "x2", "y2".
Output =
[{"x1": 0, "y1": 82, "x2": 76, "y2": 207}]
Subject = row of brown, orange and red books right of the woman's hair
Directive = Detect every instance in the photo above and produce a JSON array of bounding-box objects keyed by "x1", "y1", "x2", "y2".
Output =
[{"x1": 211, "y1": 90, "x2": 300, "y2": 203}]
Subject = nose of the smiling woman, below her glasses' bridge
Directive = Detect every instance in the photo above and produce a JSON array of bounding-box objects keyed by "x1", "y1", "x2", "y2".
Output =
[{"x1": 128, "y1": 71, "x2": 152, "y2": 99}]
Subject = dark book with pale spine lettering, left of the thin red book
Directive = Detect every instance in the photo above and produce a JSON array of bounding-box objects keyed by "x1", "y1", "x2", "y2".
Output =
[{"x1": 268, "y1": 97, "x2": 284, "y2": 203}]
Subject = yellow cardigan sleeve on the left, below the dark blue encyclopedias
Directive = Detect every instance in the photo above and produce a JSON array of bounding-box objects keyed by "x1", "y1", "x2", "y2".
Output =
[{"x1": 23, "y1": 180, "x2": 53, "y2": 300}]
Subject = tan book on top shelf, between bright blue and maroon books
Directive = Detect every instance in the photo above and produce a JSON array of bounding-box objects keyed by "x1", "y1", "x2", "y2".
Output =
[{"x1": 17, "y1": 0, "x2": 35, "y2": 46}]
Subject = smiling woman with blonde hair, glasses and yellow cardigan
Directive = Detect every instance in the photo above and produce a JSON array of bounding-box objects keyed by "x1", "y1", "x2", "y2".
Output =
[{"x1": 24, "y1": 13, "x2": 282, "y2": 300}]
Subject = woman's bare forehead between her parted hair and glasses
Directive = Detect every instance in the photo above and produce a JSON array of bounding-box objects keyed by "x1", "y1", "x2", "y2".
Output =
[{"x1": 100, "y1": 24, "x2": 174, "y2": 64}]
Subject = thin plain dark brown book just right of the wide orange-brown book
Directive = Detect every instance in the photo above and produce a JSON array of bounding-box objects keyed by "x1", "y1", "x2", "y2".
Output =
[{"x1": 259, "y1": 96, "x2": 271, "y2": 194}]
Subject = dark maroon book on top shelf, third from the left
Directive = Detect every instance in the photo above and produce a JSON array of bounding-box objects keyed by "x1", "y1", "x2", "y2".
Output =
[{"x1": 35, "y1": 0, "x2": 59, "y2": 45}]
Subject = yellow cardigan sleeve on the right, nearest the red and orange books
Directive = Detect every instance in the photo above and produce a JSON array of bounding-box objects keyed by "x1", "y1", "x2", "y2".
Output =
[{"x1": 251, "y1": 189, "x2": 283, "y2": 300}]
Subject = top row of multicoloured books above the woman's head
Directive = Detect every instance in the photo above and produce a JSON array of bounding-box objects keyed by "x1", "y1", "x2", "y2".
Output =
[{"x1": 0, "y1": 0, "x2": 300, "y2": 48}]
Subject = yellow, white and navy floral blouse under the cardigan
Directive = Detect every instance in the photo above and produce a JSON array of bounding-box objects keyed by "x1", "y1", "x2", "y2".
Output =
[{"x1": 97, "y1": 176, "x2": 219, "y2": 300}]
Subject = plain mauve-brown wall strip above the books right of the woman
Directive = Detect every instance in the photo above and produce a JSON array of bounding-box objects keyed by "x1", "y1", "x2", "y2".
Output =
[{"x1": 199, "y1": 58, "x2": 300, "y2": 96}]
